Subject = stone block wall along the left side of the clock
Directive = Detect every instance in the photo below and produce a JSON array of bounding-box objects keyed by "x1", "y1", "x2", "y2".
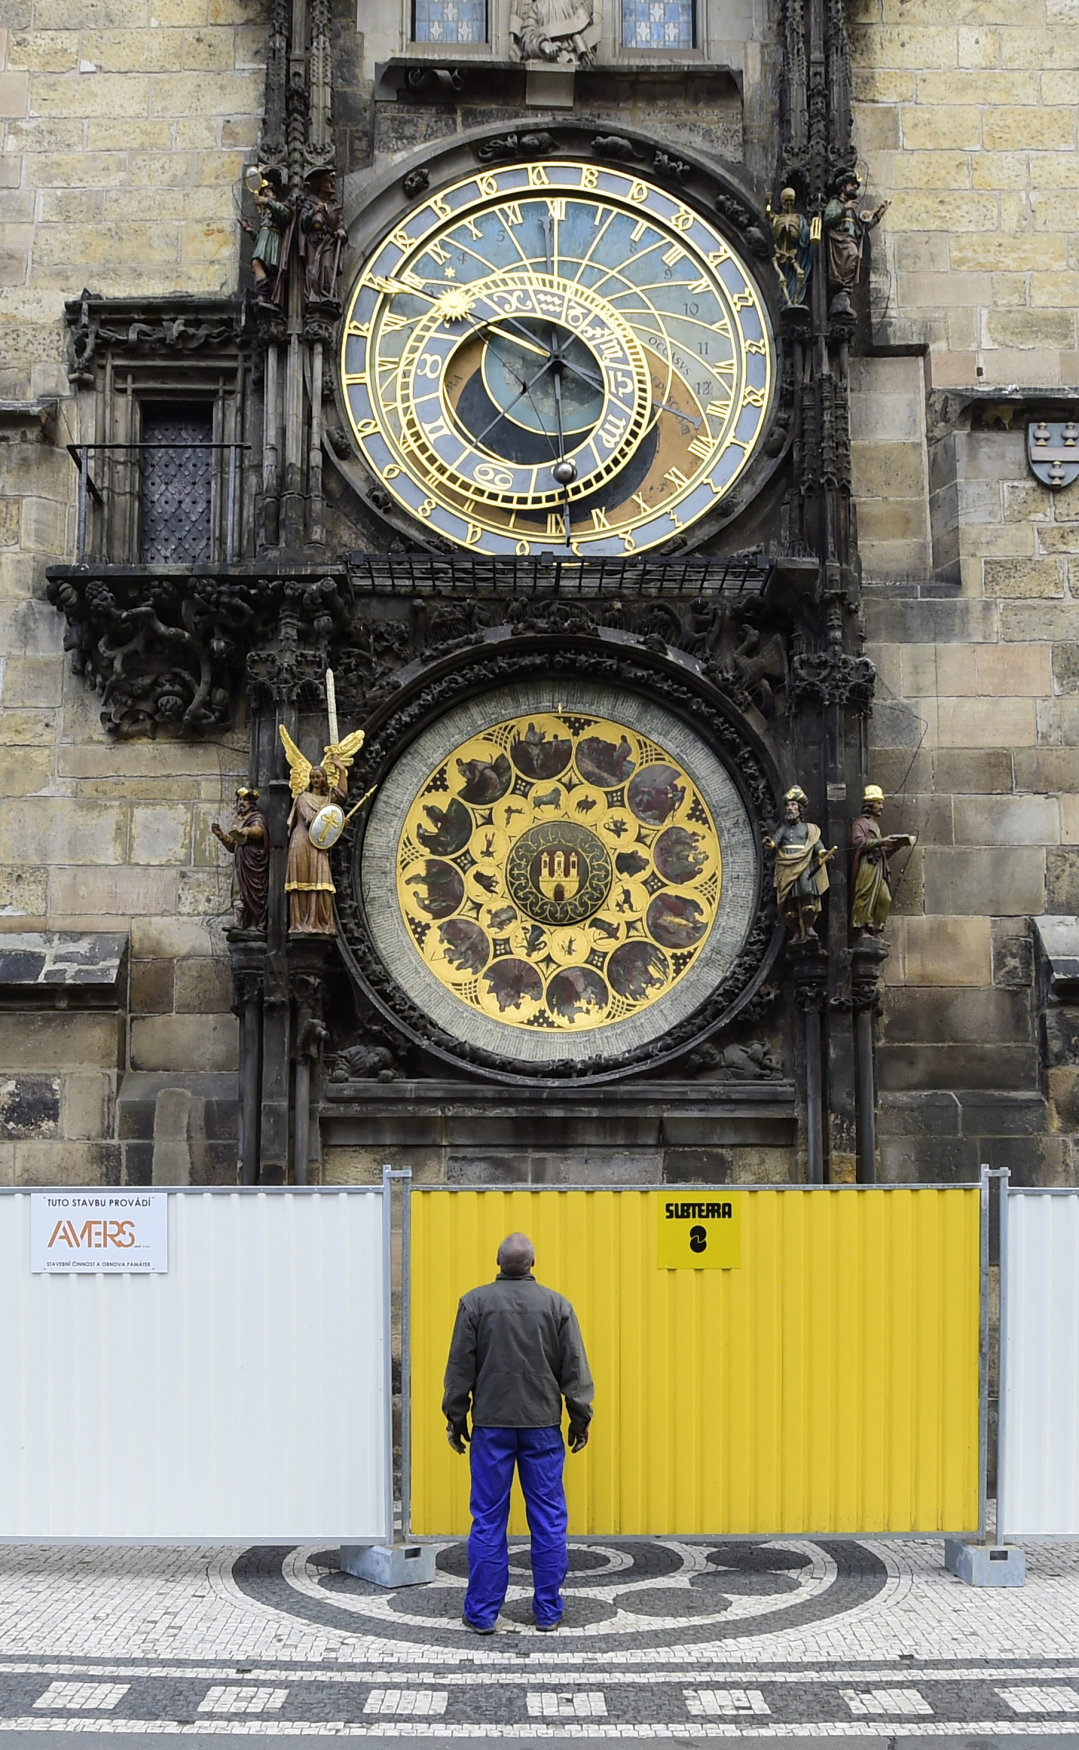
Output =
[{"x1": 0, "y1": 0, "x2": 255, "y2": 1183}]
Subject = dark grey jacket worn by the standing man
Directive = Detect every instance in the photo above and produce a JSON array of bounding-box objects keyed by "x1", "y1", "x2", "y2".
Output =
[{"x1": 442, "y1": 1272, "x2": 593, "y2": 1428}]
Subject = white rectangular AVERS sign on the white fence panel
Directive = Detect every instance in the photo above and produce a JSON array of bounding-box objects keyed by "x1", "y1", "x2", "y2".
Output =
[{"x1": 30, "y1": 1192, "x2": 168, "y2": 1276}]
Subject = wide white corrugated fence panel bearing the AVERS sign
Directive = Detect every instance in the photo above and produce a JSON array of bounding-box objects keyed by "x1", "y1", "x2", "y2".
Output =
[{"x1": 0, "y1": 1190, "x2": 390, "y2": 1542}]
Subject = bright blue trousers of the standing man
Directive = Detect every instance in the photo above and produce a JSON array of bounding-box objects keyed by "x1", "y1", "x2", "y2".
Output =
[{"x1": 465, "y1": 1428, "x2": 570, "y2": 1629}]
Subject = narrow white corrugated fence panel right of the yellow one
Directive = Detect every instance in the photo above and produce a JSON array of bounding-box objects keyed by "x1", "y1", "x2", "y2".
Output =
[{"x1": 1000, "y1": 1192, "x2": 1079, "y2": 1538}]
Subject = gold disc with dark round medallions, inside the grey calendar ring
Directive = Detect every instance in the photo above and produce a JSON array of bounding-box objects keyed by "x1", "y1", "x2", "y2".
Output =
[{"x1": 397, "y1": 711, "x2": 722, "y2": 1033}]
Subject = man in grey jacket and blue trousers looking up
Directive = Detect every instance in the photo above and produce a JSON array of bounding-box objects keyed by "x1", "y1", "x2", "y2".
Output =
[{"x1": 442, "y1": 1234, "x2": 593, "y2": 1635}]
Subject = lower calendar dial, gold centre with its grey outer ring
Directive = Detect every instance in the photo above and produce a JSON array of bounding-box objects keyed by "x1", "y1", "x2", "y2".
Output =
[{"x1": 355, "y1": 683, "x2": 755, "y2": 1061}]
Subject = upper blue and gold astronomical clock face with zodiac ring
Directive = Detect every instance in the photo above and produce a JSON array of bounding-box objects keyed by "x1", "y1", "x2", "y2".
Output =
[{"x1": 341, "y1": 159, "x2": 775, "y2": 558}]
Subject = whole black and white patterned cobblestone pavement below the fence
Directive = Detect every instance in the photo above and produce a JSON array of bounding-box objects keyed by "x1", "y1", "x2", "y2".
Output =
[{"x1": 0, "y1": 1538, "x2": 1079, "y2": 1750}]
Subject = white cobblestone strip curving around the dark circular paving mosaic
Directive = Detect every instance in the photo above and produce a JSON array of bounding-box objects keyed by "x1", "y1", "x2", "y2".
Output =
[{"x1": 0, "y1": 1540, "x2": 1079, "y2": 1671}]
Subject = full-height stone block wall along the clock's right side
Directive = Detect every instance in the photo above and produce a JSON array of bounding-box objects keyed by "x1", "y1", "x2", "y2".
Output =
[{"x1": 853, "y1": 0, "x2": 1079, "y2": 1183}]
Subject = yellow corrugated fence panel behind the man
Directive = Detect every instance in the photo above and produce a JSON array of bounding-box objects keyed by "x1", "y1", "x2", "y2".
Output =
[{"x1": 413, "y1": 1187, "x2": 979, "y2": 1537}]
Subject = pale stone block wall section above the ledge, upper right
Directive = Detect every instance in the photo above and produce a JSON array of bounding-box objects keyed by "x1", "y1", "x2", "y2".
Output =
[{"x1": 852, "y1": 0, "x2": 1079, "y2": 389}]
